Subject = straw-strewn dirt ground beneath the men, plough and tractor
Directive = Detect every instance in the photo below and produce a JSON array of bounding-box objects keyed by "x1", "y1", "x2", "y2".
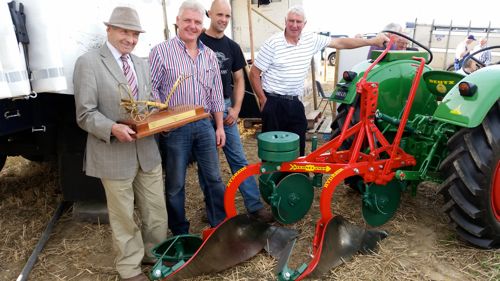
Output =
[{"x1": 0, "y1": 83, "x2": 500, "y2": 281}]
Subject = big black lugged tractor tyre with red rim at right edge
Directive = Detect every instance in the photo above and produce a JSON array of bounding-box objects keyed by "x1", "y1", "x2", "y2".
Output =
[{"x1": 440, "y1": 102, "x2": 500, "y2": 249}]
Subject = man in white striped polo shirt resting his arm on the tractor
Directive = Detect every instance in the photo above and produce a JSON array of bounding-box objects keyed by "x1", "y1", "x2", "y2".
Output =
[{"x1": 250, "y1": 6, "x2": 389, "y2": 155}]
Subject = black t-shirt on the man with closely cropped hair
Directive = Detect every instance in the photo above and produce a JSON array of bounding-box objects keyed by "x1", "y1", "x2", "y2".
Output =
[{"x1": 200, "y1": 33, "x2": 246, "y2": 99}]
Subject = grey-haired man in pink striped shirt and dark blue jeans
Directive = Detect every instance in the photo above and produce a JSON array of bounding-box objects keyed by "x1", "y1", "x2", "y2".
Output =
[{"x1": 149, "y1": 0, "x2": 226, "y2": 235}]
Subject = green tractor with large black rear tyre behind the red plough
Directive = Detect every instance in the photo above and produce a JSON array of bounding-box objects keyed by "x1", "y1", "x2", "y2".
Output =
[{"x1": 331, "y1": 32, "x2": 500, "y2": 249}]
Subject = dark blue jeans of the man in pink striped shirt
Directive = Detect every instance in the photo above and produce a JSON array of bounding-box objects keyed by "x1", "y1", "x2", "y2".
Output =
[{"x1": 160, "y1": 119, "x2": 226, "y2": 235}]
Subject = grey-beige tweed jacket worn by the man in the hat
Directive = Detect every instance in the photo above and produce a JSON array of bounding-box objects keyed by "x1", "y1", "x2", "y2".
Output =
[{"x1": 73, "y1": 44, "x2": 161, "y2": 180}]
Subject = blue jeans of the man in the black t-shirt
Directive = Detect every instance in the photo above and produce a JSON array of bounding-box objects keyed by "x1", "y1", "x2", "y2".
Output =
[{"x1": 199, "y1": 99, "x2": 264, "y2": 213}]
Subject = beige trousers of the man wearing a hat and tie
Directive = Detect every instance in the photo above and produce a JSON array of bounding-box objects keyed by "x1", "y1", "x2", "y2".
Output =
[{"x1": 101, "y1": 165, "x2": 167, "y2": 278}]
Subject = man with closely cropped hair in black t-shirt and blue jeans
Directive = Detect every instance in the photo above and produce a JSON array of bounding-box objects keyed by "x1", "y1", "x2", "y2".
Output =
[{"x1": 200, "y1": 0, "x2": 274, "y2": 222}]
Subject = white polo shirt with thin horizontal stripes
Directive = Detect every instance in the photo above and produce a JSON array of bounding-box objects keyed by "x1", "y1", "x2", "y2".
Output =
[{"x1": 254, "y1": 32, "x2": 330, "y2": 96}]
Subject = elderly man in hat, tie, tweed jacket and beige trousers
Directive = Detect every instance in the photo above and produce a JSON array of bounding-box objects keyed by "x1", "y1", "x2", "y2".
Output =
[{"x1": 73, "y1": 7, "x2": 167, "y2": 281}]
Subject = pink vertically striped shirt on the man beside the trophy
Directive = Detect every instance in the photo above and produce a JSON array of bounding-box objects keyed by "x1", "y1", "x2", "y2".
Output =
[{"x1": 149, "y1": 37, "x2": 224, "y2": 113}]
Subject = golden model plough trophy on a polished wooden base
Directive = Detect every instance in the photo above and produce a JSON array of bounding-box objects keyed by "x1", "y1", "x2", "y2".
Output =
[{"x1": 118, "y1": 72, "x2": 210, "y2": 138}]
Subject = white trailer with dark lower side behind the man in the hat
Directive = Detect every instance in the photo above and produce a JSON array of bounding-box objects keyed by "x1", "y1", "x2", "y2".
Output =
[{"x1": 0, "y1": 0, "x2": 167, "y2": 202}]
